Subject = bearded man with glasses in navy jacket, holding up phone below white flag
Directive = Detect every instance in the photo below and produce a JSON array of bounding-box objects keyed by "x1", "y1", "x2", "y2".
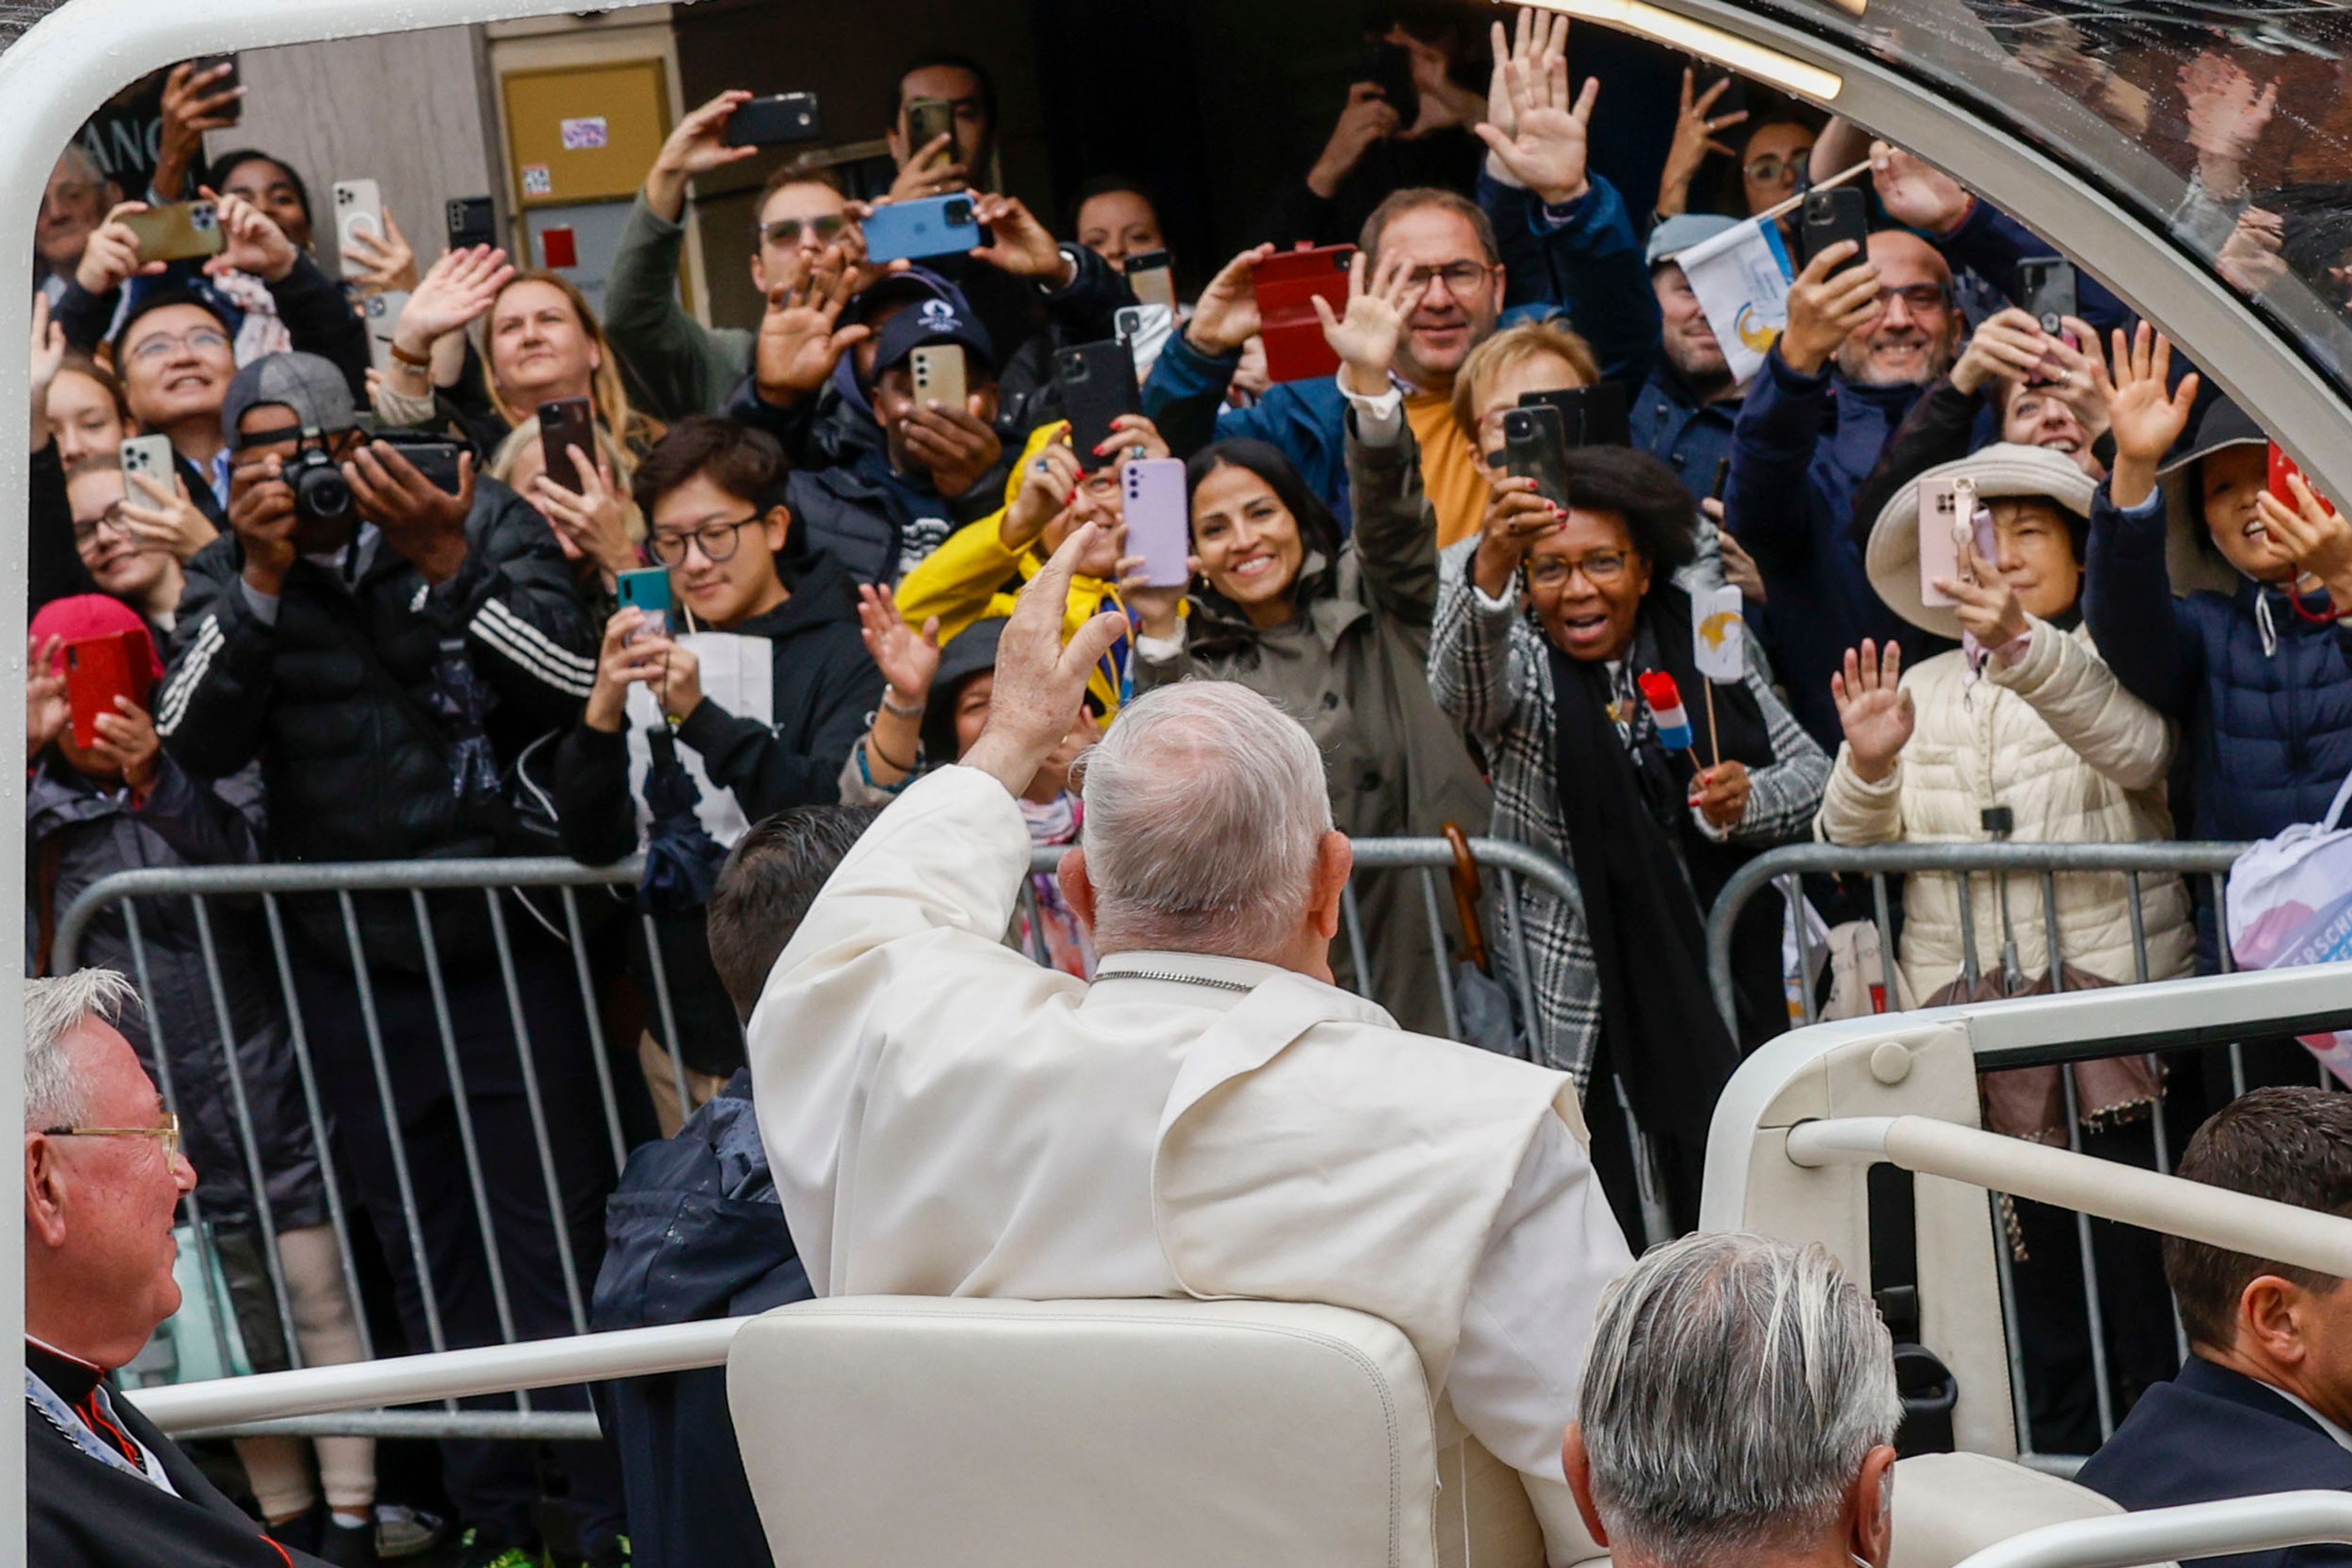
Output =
[{"x1": 1724, "y1": 230, "x2": 1962, "y2": 750}]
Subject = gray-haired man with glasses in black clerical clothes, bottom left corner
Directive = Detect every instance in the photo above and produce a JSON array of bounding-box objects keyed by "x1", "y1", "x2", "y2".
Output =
[{"x1": 23, "y1": 968, "x2": 341, "y2": 1568}]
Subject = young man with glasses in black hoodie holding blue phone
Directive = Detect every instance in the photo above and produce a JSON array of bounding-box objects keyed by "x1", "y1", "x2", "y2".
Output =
[{"x1": 552, "y1": 416, "x2": 891, "y2": 1131}]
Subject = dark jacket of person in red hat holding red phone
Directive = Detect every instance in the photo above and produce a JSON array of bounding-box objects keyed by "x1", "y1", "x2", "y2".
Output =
[{"x1": 23, "y1": 748, "x2": 327, "y2": 1229}]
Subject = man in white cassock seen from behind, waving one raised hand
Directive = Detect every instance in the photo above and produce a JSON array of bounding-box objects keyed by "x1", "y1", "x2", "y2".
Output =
[{"x1": 750, "y1": 524, "x2": 1632, "y2": 1563}]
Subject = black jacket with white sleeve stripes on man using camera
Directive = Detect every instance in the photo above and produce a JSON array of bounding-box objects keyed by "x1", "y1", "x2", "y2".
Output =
[{"x1": 155, "y1": 477, "x2": 597, "y2": 971}]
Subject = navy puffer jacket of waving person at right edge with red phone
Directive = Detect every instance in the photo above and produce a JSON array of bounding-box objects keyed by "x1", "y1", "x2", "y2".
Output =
[{"x1": 2084, "y1": 484, "x2": 2352, "y2": 839}]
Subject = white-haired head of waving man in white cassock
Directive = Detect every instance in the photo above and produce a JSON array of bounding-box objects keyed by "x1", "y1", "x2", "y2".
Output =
[{"x1": 1082, "y1": 679, "x2": 1331, "y2": 959}]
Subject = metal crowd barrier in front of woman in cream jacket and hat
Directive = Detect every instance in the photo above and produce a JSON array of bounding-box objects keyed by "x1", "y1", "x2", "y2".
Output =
[{"x1": 1708, "y1": 842, "x2": 2333, "y2": 1474}]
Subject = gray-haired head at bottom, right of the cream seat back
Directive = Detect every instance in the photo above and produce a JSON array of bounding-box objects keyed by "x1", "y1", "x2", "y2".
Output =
[{"x1": 1562, "y1": 1232, "x2": 1903, "y2": 1568}]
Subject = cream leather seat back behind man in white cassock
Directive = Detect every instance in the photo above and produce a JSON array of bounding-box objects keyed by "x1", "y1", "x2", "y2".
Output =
[{"x1": 727, "y1": 1298, "x2": 1543, "y2": 1568}]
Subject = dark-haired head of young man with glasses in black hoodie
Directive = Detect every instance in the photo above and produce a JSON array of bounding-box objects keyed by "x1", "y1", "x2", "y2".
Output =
[{"x1": 635, "y1": 414, "x2": 793, "y2": 632}]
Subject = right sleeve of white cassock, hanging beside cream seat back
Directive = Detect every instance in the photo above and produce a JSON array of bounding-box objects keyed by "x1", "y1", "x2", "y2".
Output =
[{"x1": 1447, "y1": 1117, "x2": 1632, "y2": 1568}]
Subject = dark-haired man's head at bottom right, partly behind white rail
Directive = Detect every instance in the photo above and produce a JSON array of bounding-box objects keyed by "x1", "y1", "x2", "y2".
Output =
[{"x1": 2164, "y1": 1088, "x2": 2352, "y2": 1425}]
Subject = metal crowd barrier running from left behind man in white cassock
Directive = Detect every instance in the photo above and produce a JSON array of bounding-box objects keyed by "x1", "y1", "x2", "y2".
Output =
[{"x1": 51, "y1": 839, "x2": 1599, "y2": 1439}]
